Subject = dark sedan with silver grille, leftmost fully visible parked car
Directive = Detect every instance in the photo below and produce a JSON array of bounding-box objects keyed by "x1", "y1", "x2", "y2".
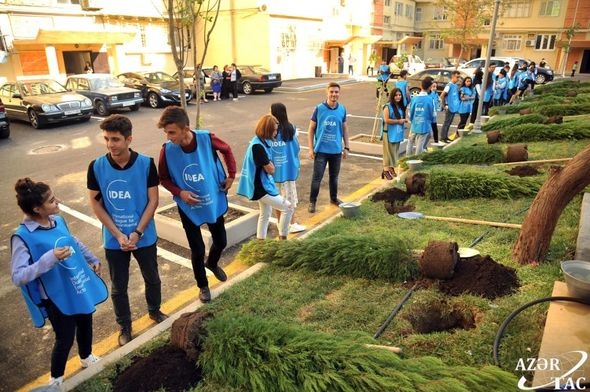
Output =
[{"x1": 0, "y1": 79, "x2": 94, "y2": 128}]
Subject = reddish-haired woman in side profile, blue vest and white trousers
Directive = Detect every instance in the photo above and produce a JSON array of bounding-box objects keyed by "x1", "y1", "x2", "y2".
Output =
[{"x1": 237, "y1": 114, "x2": 293, "y2": 240}]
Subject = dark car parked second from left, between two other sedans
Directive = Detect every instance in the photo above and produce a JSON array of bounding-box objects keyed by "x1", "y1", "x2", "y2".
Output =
[{"x1": 66, "y1": 73, "x2": 143, "y2": 116}]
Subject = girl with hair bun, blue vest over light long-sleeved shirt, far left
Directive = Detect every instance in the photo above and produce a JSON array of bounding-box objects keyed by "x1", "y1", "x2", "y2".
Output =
[{"x1": 11, "y1": 178, "x2": 107, "y2": 387}]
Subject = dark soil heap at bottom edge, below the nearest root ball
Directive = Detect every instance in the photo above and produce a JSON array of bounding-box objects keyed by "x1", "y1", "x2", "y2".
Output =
[{"x1": 113, "y1": 345, "x2": 202, "y2": 392}]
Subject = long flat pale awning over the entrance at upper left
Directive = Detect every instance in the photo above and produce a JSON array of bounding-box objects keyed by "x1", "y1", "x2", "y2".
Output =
[{"x1": 14, "y1": 29, "x2": 136, "y2": 45}]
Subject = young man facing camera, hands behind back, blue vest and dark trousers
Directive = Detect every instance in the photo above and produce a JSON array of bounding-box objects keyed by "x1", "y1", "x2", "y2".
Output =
[{"x1": 307, "y1": 82, "x2": 350, "y2": 213}]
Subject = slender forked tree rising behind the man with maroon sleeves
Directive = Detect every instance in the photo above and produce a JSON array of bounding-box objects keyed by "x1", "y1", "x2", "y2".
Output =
[{"x1": 166, "y1": 0, "x2": 221, "y2": 122}]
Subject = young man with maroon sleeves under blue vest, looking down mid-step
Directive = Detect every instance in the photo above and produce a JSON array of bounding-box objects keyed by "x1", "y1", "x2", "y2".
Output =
[{"x1": 158, "y1": 106, "x2": 236, "y2": 303}]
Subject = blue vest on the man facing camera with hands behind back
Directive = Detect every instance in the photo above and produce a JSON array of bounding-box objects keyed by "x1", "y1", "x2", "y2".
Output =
[{"x1": 313, "y1": 103, "x2": 346, "y2": 154}]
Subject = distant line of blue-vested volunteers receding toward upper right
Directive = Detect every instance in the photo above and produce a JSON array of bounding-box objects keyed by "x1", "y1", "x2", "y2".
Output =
[{"x1": 376, "y1": 61, "x2": 537, "y2": 180}]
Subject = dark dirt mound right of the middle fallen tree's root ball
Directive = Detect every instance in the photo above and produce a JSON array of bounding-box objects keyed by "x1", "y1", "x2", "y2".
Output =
[{"x1": 438, "y1": 256, "x2": 520, "y2": 299}]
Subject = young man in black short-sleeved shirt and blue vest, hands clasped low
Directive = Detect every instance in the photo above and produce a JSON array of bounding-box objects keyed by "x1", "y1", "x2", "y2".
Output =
[{"x1": 87, "y1": 114, "x2": 168, "y2": 346}]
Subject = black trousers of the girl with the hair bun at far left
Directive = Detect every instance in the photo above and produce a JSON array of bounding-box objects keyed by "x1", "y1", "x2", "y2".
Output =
[{"x1": 42, "y1": 299, "x2": 92, "y2": 378}]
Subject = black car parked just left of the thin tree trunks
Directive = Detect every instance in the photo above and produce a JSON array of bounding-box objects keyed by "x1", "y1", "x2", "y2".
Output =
[{"x1": 117, "y1": 71, "x2": 193, "y2": 108}]
